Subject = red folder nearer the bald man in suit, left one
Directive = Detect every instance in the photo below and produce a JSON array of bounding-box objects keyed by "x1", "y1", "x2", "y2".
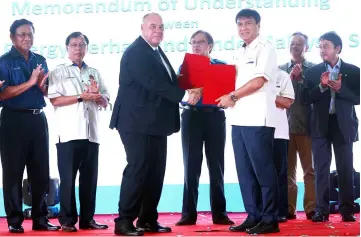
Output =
[{"x1": 179, "y1": 53, "x2": 210, "y2": 90}]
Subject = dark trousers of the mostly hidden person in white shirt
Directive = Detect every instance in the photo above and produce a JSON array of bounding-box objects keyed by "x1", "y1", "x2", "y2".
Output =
[{"x1": 273, "y1": 139, "x2": 288, "y2": 217}]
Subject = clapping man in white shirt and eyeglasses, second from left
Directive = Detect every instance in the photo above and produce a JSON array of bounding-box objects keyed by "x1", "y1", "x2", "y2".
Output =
[{"x1": 48, "y1": 32, "x2": 109, "y2": 232}]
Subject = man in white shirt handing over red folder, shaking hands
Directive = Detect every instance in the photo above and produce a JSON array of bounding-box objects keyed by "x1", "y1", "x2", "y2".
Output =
[{"x1": 217, "y1": 9, "x2": 279, "y2": 234}]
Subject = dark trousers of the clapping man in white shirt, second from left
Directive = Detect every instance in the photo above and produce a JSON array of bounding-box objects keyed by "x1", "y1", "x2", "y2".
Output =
[{"x1": 56, "y1": 140, "x2": 99, "y2": 225}]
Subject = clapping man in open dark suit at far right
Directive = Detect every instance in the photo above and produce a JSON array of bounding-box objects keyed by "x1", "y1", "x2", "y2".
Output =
[{"x1": 303, "y1": 32, "x2": 360, "y2": 222}]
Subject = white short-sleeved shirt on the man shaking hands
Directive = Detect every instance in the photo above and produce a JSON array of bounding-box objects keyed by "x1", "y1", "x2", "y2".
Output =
[{"x1": 227, "y1": 36, "x2": 278, "y2": 127}]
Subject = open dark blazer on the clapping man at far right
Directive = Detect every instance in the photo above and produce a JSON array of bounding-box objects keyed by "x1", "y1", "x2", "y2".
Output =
[{"x1": 303, "y1": 60, "x2": 360, "y2": 143}]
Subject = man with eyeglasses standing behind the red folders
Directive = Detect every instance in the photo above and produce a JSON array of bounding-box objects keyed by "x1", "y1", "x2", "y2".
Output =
[{"x1": 176, "y1": 30, "x2": 234, "y2": 225}]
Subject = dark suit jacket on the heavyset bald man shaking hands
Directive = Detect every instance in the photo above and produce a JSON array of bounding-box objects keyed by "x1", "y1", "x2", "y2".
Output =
[{"x1": 110, "y1": 37, "x2": 185, "y2": 136}]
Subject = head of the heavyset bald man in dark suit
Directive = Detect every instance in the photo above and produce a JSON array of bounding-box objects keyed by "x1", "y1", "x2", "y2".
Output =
[{"x1": 141, "y1": 13, "x2": 164, "y2": 47}]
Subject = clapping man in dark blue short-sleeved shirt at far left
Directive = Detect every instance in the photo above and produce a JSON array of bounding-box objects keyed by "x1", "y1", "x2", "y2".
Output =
[{"x1": 0, "y1": 19, "x2": 60, "y2": 233}]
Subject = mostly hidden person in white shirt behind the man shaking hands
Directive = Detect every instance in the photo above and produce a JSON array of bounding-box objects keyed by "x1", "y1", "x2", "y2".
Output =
[{"x1": 273, "y1": 69, "x2": 295, "y2": 222}]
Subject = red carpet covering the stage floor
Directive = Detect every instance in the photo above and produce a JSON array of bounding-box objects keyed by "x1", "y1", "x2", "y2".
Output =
[{"x1": 0, "y1": 213, "x2": 360, "y2": 237}]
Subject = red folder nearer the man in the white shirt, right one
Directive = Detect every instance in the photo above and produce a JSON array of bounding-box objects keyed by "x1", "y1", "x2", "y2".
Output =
[{"x1": 202, "y1": 64, "x2": 236, "y2": 104}]
